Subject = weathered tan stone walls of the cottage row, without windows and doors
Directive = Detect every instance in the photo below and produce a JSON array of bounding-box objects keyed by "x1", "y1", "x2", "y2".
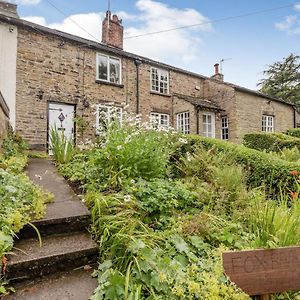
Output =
[{"x1": 0, "y1": 9, "x2": 294, "y2": 148}]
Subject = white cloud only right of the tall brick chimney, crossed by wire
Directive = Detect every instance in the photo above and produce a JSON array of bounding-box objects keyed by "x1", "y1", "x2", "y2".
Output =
[{"x1": 125, "y1": 0, "x2": 212, "y2": 66}]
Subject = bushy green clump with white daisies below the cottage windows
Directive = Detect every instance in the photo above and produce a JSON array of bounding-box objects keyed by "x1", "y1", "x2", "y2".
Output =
[{"x1": 60, "y1": 123, "x2": 175, "y2": 191}]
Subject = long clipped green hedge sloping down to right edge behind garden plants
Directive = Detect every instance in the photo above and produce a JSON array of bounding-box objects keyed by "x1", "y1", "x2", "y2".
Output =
[{"x1": 175, "y1": 135, "x2": 300, "y2": 195}]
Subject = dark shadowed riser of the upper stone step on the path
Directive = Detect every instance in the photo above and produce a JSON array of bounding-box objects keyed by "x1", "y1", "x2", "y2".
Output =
[{"x1": 18, "y1": 214, "x2": 90, "y2": 240}]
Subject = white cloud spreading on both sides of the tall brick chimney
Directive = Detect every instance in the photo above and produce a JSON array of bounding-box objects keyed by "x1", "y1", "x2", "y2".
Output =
[{"x1": 24, "y1": 0, "x2": 212, "y2": 67}]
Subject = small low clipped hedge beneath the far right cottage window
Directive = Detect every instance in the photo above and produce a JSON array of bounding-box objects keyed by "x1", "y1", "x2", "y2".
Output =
[{"x1": 243, "y1": 133, "x2": 300, "y2": 152}]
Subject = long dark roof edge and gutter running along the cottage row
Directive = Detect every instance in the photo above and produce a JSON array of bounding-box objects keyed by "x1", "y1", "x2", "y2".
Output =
[{"x1": 0, "y1": 13, "x2": 295, "y2": 108}]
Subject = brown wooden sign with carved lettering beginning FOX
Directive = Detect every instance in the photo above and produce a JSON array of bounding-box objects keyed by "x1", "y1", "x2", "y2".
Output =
[{"x1": 223, "y1": 247, "x2": 300, "y2": 296}]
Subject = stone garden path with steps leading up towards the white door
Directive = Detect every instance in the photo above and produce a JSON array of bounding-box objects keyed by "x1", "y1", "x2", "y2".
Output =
[{"x1": 4, "y1": 159, "x2": 98, "y2": 300}]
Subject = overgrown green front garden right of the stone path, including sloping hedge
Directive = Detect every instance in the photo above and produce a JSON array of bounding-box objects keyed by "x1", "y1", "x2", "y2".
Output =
[{"x1": 51, "y1": 120, "x2": 300, "y2": 300}]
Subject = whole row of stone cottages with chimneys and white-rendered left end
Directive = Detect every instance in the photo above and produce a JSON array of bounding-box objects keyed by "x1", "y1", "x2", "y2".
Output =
[{"x1": 0, "y1": 1, "x2": 296, "y2": 148}]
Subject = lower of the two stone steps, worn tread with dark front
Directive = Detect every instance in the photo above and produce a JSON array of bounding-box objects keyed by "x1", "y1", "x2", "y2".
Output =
[{"x1": 6, "y1": 232, "x2": 98, "y2": 282}]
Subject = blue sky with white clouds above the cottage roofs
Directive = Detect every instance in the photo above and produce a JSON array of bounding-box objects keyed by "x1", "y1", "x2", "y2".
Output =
[{"x1": 11, "y1": 0, "x2": 300, "y2": 89}]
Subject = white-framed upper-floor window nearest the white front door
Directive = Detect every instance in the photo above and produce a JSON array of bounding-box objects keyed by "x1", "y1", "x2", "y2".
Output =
[{"x1": 97, "y1": 53, "x2": 121, "y2": 84}]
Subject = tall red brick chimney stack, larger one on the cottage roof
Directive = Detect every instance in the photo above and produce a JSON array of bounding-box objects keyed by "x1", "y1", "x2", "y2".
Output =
[{"x1": 102, "y1": 10, "x2": 124, "y2": 49}]
